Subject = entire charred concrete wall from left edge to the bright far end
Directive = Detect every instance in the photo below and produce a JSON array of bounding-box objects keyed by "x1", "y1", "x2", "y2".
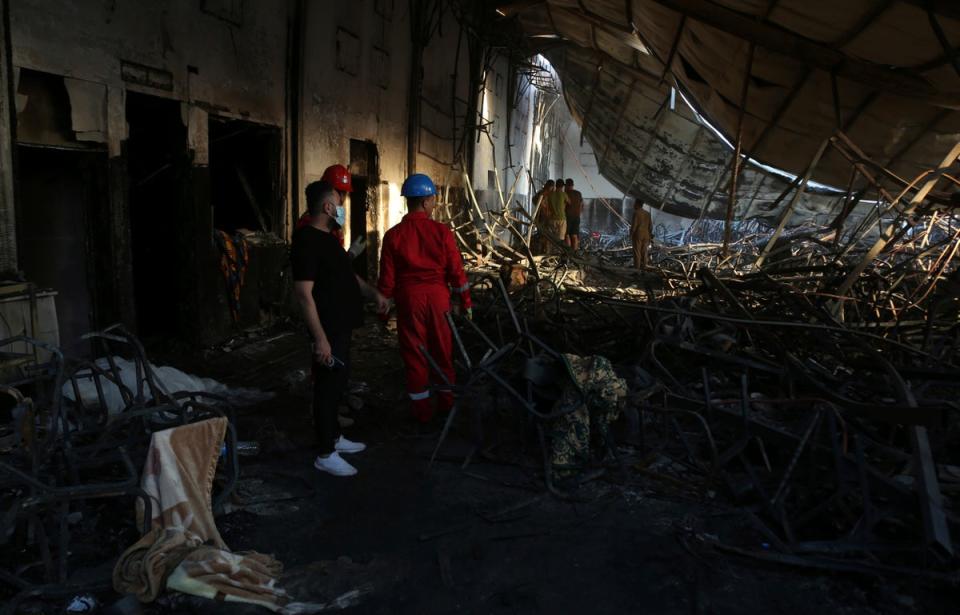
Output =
[{"x1": 0, "y1": 0, "x2": 563, "y2": 343}]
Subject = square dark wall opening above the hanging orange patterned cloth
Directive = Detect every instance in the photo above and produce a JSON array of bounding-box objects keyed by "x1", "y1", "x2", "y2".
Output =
[{"x1": 209, "y1": 117, "x2": 283, "y2": 233}]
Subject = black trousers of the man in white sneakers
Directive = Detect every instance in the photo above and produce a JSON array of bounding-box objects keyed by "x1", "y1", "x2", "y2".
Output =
[{"x1": 311, "y1": 330, "x2": 351, "y2": 456}]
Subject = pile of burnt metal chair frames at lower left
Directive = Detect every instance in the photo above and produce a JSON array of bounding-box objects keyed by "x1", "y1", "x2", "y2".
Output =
[{"x1": 0, "y1": 325, "x2": 239, "y2": 612}]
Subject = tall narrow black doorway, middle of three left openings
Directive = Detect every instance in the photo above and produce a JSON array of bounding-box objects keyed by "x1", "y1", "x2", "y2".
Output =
[{"x1": 127, "y1": 92, "x2": 188, "y2": 339}]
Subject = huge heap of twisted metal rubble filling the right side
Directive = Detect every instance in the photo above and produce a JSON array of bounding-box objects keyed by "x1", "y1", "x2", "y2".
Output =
[{"x1": 434, "y1": 173, "x2": 960, "y2": 586}]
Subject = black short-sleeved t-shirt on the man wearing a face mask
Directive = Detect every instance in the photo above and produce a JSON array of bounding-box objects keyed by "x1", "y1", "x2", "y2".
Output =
[{"x1": 290, "y1": 226, "x2": 363, "y2": 333}]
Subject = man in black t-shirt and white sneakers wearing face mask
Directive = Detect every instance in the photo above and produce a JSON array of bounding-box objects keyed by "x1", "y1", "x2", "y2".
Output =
[{"x1": 290, "y1": 182, "x2": 389, "y2": 476}]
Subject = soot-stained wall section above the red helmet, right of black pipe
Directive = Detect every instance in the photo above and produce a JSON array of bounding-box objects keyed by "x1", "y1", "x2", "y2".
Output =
[{"x1": 297, "y1": 0, "x2": 470, "y2": 255}]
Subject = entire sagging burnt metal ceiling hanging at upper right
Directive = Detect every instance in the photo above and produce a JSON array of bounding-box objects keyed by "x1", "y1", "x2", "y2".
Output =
[{"x1": 501, "y1": 0, "x2": 960, "y2": 223}]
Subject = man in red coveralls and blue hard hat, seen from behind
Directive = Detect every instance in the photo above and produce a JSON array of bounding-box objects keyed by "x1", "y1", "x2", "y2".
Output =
[{"x1": 378, "y1": 173, "x2": 473, "y2": 423}]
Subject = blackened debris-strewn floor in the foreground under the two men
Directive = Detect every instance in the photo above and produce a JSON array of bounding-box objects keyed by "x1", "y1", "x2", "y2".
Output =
[{"x1": 133, "y1": 324, "x2": 957, "y2": 613}]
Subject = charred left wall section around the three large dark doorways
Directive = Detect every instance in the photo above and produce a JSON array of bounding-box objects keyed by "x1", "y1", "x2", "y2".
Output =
[{"x1": 9, "y1": 0, "x2": 288, "y2": 346}]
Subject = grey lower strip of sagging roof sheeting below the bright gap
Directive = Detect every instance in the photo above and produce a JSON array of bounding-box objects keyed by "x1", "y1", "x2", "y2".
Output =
[{"x1": 547, "y1": 47, "x2": 839, "y2": 224}]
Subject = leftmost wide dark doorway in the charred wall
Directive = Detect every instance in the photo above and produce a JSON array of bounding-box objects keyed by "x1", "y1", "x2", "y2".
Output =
[{"x1": 17, "y1": 145, "x2": 107, "y2": 352}]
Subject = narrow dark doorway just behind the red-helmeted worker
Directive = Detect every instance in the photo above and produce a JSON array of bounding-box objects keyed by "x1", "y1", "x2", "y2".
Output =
[{"x1": 350, "y1": 139, "x2": 380, "y2": 280}]
